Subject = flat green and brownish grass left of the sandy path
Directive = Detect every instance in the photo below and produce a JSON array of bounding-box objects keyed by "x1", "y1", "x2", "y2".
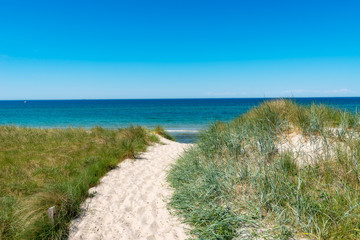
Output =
[{"x1": 0, "y1": 126, "x2": 158, "y2": 239}]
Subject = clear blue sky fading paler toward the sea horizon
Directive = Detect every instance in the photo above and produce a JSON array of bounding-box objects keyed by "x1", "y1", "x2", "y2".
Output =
[{"x1": 0, "y1": 0, "x2": 360, "y2": 100}]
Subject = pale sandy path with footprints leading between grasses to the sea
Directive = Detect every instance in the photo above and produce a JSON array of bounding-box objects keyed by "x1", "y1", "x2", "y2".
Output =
[{"x1": 69, "y1": 138, "x2": 191, "y2": 240}]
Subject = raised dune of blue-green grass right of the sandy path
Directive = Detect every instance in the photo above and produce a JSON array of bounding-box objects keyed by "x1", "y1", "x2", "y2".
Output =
[{"x1": 168, "y1": 100, "x2": 360, "y2": 239}]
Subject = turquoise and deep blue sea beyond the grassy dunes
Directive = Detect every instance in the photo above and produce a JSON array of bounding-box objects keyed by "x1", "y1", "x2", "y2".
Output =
[{"x1": 0, "y1": 97, "x2": 360, "y2": 143}]
